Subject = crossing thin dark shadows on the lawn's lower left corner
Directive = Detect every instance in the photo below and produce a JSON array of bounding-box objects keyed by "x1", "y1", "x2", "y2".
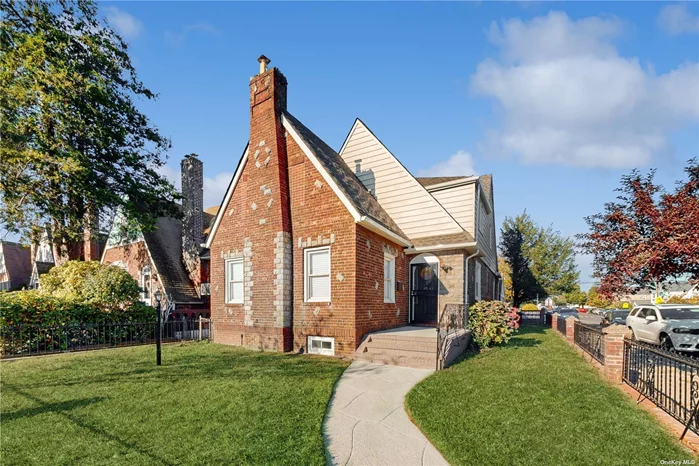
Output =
[{"x1": 0, "y1": 383, "x2": 172, "y2": 465}]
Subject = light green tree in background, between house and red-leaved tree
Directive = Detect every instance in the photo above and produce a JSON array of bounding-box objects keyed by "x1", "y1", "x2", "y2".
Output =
[{"x1": 502, "y1": 210, "x2": 580, "y2": 297}]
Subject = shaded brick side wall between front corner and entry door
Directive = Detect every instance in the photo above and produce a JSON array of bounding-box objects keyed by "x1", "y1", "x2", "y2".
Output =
[{"x1": 354, "y1": 226, "x2": 409, "y2": 346}]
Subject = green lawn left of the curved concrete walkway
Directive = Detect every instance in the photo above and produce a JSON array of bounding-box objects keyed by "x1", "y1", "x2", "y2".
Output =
[{"x1": 0, "y1": 343, "x2": 347, "y2": 466}]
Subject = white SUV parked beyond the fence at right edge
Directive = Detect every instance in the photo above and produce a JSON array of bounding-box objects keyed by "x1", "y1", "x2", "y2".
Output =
[{"x1": 626, "y1": 304, "x2": 699, "y2": 351}]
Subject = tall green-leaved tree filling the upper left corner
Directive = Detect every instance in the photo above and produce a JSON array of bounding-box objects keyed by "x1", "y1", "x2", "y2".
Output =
[{"x1": 0, "y1": 0, "x2": 179, "y2": 262}]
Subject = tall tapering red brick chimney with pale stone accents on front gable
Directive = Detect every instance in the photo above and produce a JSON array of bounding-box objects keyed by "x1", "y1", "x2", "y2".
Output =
[{"x1": 245, "y1": 55, "x2": 293, "y2": 351}]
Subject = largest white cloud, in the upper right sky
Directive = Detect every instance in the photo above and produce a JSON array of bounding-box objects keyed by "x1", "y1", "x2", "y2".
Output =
[{"x1": 471, "y1": 12, "x2": 699, "y2": 168}]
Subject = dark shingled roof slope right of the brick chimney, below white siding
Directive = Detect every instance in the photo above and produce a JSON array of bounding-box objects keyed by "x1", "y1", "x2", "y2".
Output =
[{"x1": 284, "y1": 112, "x2": 407, "y2": 238}]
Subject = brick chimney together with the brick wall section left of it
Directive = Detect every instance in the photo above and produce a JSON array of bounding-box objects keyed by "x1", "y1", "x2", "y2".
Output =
[{"x1": 211, "y1": 68, "x2": 292, "y2": 351}]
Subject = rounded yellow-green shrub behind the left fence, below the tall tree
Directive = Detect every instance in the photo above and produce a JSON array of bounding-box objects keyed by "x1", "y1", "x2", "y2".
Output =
[{"x1": 41, "y1": 261, "x2": 140, "y2": 310}]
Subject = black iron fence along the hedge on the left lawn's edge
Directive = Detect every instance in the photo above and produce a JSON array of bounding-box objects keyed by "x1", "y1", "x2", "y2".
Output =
[{"x1": 0, "y1": 318, "x2": 212, "y2": 358}]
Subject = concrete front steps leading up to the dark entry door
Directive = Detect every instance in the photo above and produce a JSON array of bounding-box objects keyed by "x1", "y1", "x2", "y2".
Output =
[{"x1": 354, "y1": 327, "x2": 437, "y2": 370}]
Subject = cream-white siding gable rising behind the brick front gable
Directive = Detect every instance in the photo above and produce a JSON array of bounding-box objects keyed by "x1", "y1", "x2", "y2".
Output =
[{"x1": 340, "y1": 120, "x2": 463, "y2": 238}]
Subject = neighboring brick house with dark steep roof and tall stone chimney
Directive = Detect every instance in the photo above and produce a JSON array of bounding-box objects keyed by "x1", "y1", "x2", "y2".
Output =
[{"x1": 101, "y1": 154, "x2": 216, "y2": 319}]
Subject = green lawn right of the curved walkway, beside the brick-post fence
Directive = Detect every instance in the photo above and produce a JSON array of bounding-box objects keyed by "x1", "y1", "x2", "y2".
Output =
[{"x1": 406, "y1": 328, "x2": 692, "y2": 465}]
